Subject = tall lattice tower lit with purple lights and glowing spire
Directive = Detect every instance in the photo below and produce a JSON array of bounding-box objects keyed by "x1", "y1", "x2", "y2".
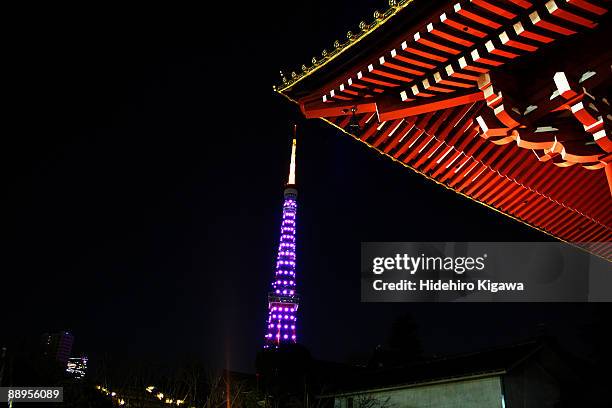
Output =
[{"x1": 264, "y1": 135, "x2": 300, "y2": 349}]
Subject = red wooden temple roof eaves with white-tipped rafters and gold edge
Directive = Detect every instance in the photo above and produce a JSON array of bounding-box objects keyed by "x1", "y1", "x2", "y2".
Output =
[{"x1": 275, "y1": 0, "x2": 612, "y2": 260}]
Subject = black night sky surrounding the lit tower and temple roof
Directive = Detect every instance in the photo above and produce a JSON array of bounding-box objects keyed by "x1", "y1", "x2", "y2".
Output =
[{"x1": 0, "y1": 0, "x2": 604, "y2": 371}]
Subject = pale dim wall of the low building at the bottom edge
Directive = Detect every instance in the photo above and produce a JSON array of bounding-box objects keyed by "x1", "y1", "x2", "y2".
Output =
[{"x1": 334, "y1": 377, "x2": 502, "y2": 408}]
